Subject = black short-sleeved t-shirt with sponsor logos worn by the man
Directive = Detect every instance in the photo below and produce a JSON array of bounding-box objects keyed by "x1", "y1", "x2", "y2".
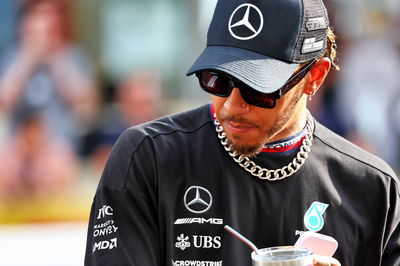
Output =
[{"x1": 85, "y1": 105, "x2": 400, "y2": 266}]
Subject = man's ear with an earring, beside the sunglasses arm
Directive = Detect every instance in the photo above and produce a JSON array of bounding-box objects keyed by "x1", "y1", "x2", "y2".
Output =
[{"x1": 304, "y1": 57, "x2": 331, "y2": 96}]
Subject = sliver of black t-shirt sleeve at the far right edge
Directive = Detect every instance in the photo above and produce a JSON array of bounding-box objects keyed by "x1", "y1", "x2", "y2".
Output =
[{"x1": 382, "y1": 176, "x2": 400, "y2": 266}]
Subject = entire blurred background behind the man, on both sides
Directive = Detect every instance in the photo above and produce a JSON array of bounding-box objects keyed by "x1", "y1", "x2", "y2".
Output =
[{"x1": 0, "y1": 0, "x2": 400, "y2": 266}]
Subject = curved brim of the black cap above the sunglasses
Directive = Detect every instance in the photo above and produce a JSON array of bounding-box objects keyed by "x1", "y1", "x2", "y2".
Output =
[{"x1": 186, "y1": 46, "x2": 299, "y2": 93}]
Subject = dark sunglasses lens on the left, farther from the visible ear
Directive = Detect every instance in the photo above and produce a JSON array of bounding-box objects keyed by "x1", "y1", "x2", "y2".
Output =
[{"x1": 198, "y1": 72, "x2": 231, "y2": 97}]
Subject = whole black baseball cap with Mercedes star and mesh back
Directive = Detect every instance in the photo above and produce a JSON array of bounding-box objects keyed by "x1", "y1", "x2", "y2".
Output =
[{"x1": 186, "y1": 0, "x2": 329, "y2": 93}]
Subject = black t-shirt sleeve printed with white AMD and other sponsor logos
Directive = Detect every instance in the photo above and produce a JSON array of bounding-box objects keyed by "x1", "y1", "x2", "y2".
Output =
[{"x1": 85, "y1": 130, "x2": 161, "y2": 266}]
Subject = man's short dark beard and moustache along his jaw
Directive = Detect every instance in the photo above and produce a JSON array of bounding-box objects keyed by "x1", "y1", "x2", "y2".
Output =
[{"x1": 219, "y1": 86, "x2": 303, "y2": 158}]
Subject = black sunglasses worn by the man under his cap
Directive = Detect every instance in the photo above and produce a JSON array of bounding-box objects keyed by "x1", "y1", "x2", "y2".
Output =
[{"x1": 196, "y1": 59, "x2": 316, "y2": 109}]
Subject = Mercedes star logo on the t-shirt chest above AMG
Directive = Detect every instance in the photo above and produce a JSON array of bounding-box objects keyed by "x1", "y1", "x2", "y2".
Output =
[{"x1": 183, "y1": 186, "x2": 212, "y2": 213}]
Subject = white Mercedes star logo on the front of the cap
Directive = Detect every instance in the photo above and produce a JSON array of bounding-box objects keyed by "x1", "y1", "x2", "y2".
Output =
[{"x1": 228, "y1": 4, "x2": 264, "y2": 40}]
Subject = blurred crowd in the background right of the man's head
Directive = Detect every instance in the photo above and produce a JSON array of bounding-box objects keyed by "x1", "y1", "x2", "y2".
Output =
[{"x1": 310, "y1": 0, "x2": 400, "y2": 172}]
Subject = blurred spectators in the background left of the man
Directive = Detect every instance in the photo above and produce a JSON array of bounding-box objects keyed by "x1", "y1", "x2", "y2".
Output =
[{"x1": 0, "y1": 0, "x2": 162, "y2": 203}]
